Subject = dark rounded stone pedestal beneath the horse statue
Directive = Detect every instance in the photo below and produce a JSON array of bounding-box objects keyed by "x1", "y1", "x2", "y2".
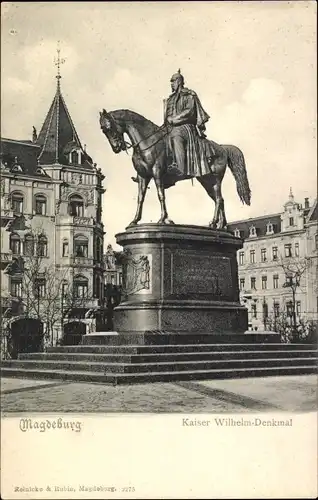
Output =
[{"x1": 114, "y1": 224, "x2": 247, "y2": 342}]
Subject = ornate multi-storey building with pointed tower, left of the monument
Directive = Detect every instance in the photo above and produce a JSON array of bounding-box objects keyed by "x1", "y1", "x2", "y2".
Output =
[{"x1": 1, "y1": 70, "x2": 104, "y2": 354}]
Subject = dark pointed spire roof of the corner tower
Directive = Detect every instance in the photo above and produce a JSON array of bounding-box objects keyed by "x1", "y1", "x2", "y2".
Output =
[{"x1": 36, "y1": 81, "x2": 93, "y2": 168}]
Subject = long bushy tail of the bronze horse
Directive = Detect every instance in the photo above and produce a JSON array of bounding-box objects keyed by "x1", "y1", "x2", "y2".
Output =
[{"x1": 223, "y1": 146, "x2": 251, "y2": 205}]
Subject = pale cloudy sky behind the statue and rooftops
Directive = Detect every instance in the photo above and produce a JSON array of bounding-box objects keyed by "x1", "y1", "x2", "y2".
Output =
[{"x1": 1, "y1": 1, "x2": 317, "y2": 248}]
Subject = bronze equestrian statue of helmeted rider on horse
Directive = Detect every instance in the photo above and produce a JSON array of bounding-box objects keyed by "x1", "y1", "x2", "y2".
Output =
[{"x1": 100, "y1": 70, "x2": 251, "y2": 229}]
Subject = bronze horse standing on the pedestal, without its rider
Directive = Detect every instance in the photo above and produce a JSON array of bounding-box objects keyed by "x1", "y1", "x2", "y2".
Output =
[{"x1": 99, "y1": 109, "x2": 251, "y2": 229}]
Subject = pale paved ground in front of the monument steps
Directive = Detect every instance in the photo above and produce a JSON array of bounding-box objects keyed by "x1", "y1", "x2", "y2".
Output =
[{"x1": 1, "y1": 375, "x2": 317, "y2": 416}]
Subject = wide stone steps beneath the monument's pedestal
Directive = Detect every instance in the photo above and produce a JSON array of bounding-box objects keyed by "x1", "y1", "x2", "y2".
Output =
[{"x1": 2, "y1": 335, "x2": 318, "y2": 384}]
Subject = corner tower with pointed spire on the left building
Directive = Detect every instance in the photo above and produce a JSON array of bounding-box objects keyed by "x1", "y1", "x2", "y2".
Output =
[{"x1": 33, "y1": 49, "x2": 105, "y2": 343}]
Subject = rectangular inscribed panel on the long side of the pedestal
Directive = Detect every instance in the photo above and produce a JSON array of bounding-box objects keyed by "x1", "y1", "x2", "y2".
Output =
[{"x1": 171, "y1": 252, "x2": 232, "y2": 298}]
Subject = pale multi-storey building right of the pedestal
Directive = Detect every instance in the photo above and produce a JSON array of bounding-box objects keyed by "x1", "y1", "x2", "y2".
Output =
[{"x1": 229, "y1": 190, "x2": 318, "y2": 330}]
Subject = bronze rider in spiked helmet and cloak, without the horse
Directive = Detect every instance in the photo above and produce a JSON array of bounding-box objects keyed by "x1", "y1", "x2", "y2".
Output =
[{"x1": 164, "y1": 69, "x2": 213, "y2": 178}]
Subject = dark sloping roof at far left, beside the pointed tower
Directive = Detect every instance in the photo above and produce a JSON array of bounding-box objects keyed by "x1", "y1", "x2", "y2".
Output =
[{"x1": 1, "y1": 138, "x2": 49, "y2": 178}]
